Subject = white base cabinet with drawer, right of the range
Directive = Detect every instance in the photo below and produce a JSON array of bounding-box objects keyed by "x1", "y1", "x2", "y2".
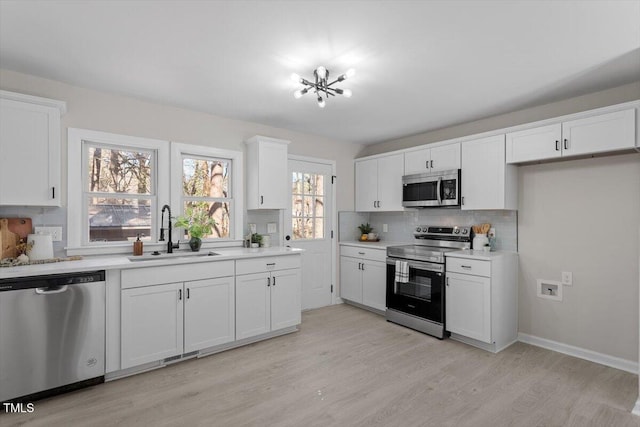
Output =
[{"x1": 445, "y1": 251, "x2": 518, "y2": 353}]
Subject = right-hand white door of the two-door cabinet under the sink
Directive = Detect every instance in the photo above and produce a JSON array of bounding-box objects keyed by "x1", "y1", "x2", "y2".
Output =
[{"x1": 184, "y1": 277, "x2": 236, "y2": 353}]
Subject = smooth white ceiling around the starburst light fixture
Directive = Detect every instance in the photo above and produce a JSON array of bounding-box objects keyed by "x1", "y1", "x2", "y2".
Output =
[{"x1": 0, "y1": 0, "x2": 640, "y2": 143}]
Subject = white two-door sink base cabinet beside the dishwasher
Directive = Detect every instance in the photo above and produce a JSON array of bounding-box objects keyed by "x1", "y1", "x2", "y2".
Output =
[{"x1": 120, "y1": 261, "x2": 235, "y2": 369}]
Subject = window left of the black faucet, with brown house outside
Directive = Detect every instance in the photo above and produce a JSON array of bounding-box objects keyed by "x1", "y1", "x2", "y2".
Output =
[{"x1": 83, "y1": 145, "x2": 157, "y2": 242}]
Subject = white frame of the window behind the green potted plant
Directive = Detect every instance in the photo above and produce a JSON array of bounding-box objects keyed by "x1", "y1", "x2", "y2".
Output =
[{"x1": 170, "y1": 141, "x2": 244, "y2": 247}]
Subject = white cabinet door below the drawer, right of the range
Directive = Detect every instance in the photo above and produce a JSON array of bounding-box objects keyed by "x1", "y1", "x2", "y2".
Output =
[{"x1": 446, "y1": 273, "x2": 492, "y2": 343}]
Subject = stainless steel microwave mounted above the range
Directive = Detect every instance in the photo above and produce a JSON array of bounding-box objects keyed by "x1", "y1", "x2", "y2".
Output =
[{"x1": 402, "y1": 169, "x2": 461, "y2": 208}]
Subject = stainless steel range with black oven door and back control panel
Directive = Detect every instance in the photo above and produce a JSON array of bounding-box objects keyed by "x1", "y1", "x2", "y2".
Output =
[{"x1": 386, "y1": 225, "x2": 471, "y2": 339}]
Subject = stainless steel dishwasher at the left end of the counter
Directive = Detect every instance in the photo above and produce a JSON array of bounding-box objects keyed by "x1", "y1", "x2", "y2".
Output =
[{"x1": 0, "y1": 271, "x2": 105, "y2": 402}]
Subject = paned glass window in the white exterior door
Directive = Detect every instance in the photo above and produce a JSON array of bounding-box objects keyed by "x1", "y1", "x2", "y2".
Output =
[{"x1": 291, "y1": 172, "x2": 325, "y2": 240}]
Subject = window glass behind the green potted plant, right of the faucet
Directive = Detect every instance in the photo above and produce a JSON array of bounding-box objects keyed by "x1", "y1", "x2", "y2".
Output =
[{"x1": 181, "y1": 156, "x2": 232, "y2": 239}]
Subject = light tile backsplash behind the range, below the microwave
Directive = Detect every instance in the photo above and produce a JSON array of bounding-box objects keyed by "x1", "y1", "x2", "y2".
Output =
[{"x1": 338, "y1": 209, "x2": 518, "y2": 251}]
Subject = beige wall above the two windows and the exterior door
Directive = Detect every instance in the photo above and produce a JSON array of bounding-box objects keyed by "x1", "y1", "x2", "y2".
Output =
[{"x1": 0, "y1": 69, "x2": 362, "y2": 210}]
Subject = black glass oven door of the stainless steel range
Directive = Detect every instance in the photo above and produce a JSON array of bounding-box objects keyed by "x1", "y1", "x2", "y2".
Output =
[{"x1": 387, "y1": 258, "x2": 444, "y2": 324}]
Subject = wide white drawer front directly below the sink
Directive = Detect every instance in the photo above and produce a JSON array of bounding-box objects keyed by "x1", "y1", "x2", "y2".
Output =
[{"x1": 121, "y1": 261, "x2": 234, "y2": 289}]
